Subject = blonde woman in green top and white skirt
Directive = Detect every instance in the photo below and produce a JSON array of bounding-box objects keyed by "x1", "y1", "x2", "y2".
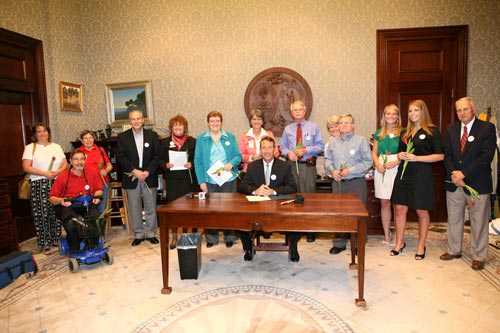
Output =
[{"x1": 372, "y1": 104, "x2": 401, "y2": 246}]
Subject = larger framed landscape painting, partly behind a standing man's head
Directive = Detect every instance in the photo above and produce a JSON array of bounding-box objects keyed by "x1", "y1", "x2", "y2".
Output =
[{"x1": 106, "y1": 81, "x2": 154, "y2": 127}]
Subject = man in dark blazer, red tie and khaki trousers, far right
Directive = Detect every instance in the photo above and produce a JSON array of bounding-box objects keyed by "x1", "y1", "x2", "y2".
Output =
[{"x1": 440, "y1": 97, "x2": 496, "y2": 270}]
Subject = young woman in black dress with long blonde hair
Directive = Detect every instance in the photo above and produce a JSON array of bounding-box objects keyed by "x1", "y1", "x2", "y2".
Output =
[{"x1": 390, "y1": 100, "x2": 444, "y2": 260}]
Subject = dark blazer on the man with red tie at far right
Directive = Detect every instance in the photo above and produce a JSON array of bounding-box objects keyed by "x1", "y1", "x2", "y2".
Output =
[{"x1": 444, "y1": 118, "x2": 497, "y2": 194}]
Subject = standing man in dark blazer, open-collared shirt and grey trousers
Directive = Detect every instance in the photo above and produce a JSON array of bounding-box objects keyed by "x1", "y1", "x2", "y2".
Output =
[{"x1": 116, "y1": 110, "x2": 160, "y2": 246}]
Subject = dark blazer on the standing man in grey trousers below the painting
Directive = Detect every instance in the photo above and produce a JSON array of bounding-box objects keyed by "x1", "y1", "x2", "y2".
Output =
[{"x1": 116, "y1": 129, "x2": 160, "y2": 189}]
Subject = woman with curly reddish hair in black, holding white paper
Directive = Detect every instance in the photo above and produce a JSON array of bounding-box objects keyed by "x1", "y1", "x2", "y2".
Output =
[{"x1": 160, "y1": 115, "x2": 200, "y2": 249}]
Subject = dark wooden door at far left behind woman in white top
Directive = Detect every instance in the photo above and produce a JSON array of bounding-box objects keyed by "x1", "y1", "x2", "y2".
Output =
[{"x1": 0, "y1": 28, "x2": 49, "y2": 245}]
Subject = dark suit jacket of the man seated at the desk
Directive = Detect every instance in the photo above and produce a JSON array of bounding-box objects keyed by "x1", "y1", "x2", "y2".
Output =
[{"x1": 239, "y1": 158, "x2": 297, "y2": 194}]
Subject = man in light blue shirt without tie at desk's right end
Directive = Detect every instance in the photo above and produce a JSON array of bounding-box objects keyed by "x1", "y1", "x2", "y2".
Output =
[{"x1": 325, "y1": 114, "x2": 373, "y2": 254}]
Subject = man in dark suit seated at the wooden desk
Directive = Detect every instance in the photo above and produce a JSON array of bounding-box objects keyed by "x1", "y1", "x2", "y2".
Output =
[{"x1": 238, "y1": 137, "x2": 300, "y2": 262}]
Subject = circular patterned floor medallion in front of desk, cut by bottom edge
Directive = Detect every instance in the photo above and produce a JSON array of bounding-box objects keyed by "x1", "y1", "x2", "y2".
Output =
[{"x1": 131, "y1": 286, "x2": 352, "y2": 333}]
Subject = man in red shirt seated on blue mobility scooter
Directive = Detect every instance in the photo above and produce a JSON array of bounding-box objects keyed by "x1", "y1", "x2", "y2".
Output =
[{"x1": 49, "y1": 150, "x2": 111, "y2": 272}]
